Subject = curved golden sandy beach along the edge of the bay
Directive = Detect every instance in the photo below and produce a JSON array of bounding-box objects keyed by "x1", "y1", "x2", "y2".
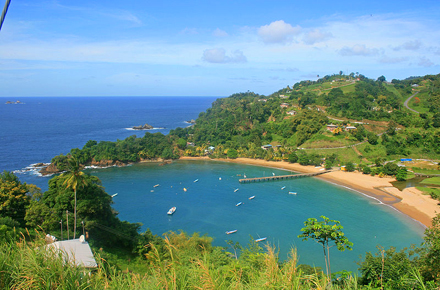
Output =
[{"x1": 181, "y1": 157, "x2": 440, "y2": 227}]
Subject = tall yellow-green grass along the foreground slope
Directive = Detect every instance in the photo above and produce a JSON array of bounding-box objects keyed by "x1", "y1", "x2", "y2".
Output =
[{"x1": 0, "y1": 234, "x2": 422, "y2": 290}]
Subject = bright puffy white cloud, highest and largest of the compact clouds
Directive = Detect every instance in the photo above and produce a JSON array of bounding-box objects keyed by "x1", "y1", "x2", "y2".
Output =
[{"x1": 258, "y1": 20, "x2": 301, "y2": 43}]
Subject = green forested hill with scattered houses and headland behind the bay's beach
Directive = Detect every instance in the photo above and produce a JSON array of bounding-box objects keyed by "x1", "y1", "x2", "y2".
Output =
[{"x1": 46, "y1": 73, "x2": 440, "y2": 172}]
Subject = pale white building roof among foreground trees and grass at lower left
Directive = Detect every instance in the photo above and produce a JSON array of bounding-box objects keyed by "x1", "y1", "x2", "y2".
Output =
[{"x1": 46, "y1": 236, "x2": 98, "y2": 268}]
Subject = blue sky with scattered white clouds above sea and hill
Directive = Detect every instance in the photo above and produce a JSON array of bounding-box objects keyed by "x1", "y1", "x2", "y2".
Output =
[{"x1": 0, "y1": 0, "x2": 440, "y2": 97}]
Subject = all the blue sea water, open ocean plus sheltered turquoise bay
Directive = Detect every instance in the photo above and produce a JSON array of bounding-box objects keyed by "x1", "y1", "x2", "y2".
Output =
[{"x1": 0, "y1": 97, "x2": 424, "y2": 272}]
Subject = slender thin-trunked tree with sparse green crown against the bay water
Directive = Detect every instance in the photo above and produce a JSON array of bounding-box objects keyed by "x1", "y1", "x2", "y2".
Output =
[{"x1": 298, "y1": 216, "x2": 353, "y2": 280}]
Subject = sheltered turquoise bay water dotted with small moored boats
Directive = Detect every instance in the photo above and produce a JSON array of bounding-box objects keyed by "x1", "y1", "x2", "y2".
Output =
[{"x1": 89, "y1": 161, "x2": 424, "y2": 271}]
